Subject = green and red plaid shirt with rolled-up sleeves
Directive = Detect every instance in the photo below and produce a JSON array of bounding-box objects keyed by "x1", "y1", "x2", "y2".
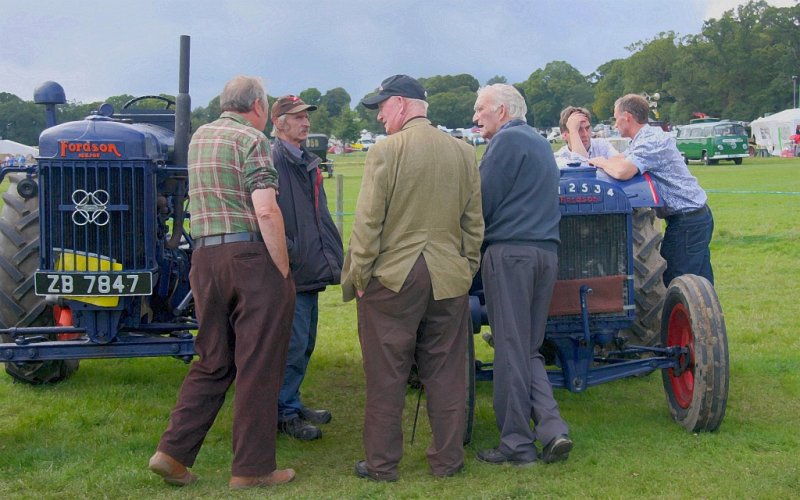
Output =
[{"x1": 189, "y1": 111, "x2": 278, "y2": 238}]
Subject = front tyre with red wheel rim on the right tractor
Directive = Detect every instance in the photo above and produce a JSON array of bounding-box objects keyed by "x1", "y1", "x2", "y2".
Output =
[{"x1": 661, "y1": 274, "x2": 730, "y2": 432}]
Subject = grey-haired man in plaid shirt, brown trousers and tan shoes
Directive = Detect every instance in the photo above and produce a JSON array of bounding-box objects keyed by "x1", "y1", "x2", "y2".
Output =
[{"x1": 149, "y1": 76, "x2": 295, "y2": 489}]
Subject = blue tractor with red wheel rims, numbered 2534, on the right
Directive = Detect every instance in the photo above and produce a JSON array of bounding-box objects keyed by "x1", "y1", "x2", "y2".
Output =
[{"x1": 467, "y1": 167, "x2": 729, "y2": 440}]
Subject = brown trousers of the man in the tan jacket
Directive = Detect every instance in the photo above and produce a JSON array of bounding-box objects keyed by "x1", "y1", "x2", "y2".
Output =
[{"x1": 358, "y1": 256, "x2": 470, "y2": 475}]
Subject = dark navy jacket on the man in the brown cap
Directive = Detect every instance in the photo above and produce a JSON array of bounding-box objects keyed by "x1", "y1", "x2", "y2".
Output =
[{"x1": 272, "y1": 139, "x2": 343, "y2": 292}]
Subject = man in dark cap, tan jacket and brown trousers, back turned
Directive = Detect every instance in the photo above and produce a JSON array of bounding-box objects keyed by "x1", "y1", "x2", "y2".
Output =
[{"x1": 342, "y1": 75, "x2": 483, "y2": 481}]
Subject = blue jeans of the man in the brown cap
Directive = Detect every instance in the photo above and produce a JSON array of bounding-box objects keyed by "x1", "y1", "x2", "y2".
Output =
[{"x1": 278, "y1": 292, "x2": 319, "y2": 422}]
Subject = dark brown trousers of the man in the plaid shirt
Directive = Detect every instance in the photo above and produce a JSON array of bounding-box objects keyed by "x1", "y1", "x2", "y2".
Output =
[{"x1": 158, "y1": 242, "x2": 295, "y2": 476}]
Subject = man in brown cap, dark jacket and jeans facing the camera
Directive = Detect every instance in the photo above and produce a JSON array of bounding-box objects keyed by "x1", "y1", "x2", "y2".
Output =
[{"x1": 272, "y1": 95, "x2": 342, "y2": 441}]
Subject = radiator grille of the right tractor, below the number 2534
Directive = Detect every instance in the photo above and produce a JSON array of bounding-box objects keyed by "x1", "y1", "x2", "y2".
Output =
[{"x1": 558, "y1": 214, "x2": 628, "y2": 280}]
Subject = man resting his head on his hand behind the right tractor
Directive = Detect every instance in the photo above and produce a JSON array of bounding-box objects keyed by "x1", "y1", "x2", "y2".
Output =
[{"x1": 555, "y1": 106, "x2": 619, "y2": 168}]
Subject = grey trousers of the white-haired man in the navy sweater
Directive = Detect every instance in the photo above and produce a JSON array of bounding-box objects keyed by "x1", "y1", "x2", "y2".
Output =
[{"x1": 481, "y1": 243, "x2": 568, "y2": 460}]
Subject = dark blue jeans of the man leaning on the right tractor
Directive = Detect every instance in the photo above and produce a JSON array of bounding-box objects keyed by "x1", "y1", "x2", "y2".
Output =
[{"x1": 661, "y1": 206, "x2": 714, "y2": 286}]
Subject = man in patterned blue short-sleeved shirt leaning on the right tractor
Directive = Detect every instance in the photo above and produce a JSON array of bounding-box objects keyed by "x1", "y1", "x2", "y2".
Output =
[{"x1": 589, "y1": 94, "x2": 714, "y2": 286}]
